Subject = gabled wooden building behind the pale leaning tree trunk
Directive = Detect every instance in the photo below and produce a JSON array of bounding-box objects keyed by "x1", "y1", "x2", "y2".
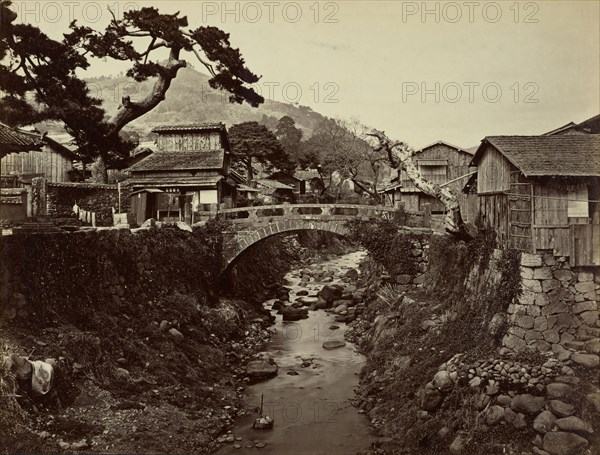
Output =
[{"x1": 380, "y1": 141, "x2": 477, "y2": 223}]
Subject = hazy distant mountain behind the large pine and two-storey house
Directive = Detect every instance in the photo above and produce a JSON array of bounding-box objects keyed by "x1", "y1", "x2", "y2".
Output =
[{"x1": 86, "y1": 68, "x2": 323, "y2": 138}]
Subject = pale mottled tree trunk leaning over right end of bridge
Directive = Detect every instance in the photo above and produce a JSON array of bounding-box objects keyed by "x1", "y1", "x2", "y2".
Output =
[{"x1": 369, "y1": 130, "x2": 474, "y2": 240}]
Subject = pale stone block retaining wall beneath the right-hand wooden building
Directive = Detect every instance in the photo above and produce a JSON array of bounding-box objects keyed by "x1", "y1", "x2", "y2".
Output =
[{"x1": 503, "y1": 253, "x2": 600, "y2": 363}]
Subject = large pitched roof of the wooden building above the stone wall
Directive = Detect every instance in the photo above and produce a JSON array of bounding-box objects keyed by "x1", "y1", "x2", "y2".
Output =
[{"x1": 471, "y1": 134, "x2": 600, "y2": 177}]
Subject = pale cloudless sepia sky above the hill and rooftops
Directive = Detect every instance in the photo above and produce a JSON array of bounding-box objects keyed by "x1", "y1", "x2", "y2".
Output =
[{"x1": 12, "y1": 0, "x2": 600, "y2": 148}]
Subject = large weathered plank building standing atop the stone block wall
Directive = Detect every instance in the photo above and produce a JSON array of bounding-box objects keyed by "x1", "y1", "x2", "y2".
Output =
[{"x1": 469, "y1": 134, "x2": 600, "y2": 265}]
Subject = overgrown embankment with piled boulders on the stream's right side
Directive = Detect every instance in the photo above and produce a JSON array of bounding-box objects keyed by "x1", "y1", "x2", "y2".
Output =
[{"x1": 348, "y1": 228, "x2": 600, "y2": 455}]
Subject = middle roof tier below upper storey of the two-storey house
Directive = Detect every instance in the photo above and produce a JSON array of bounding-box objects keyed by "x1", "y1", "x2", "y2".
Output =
[{"x1": 130, "y1": 150, "x2": 225, "y2": 172}]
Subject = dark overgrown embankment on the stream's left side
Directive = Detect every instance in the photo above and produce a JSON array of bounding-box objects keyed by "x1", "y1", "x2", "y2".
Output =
[{"x1": 0, "y1": 225, "x2": 310, "y2": 453}]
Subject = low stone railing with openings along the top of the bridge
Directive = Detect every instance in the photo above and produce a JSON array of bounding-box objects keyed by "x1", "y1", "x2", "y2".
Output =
[{"x1": 200, "y1": 204, "x2": 431, "y2": 227}]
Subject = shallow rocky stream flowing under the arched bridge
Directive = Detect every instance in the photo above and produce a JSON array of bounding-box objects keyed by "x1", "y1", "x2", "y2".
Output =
[{"x1": 217, "y1": 251, "x2": 376, "y2": 455}]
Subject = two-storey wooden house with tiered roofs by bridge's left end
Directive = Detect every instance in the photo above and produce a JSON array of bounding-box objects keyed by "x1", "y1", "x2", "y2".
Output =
[{"x1": 129, "y1": 123, "x2": 236, "y2": 224}]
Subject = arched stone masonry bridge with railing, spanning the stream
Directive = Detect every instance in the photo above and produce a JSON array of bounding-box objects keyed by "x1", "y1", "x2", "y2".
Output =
[{"x1": 217, "y1": 204, "x2": 431, "y2": 269}]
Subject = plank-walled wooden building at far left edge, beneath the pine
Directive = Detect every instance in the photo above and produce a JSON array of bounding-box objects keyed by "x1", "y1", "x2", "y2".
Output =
[{"x1": 0, "y1": 124, "x2": 77, "y2": 182}]
